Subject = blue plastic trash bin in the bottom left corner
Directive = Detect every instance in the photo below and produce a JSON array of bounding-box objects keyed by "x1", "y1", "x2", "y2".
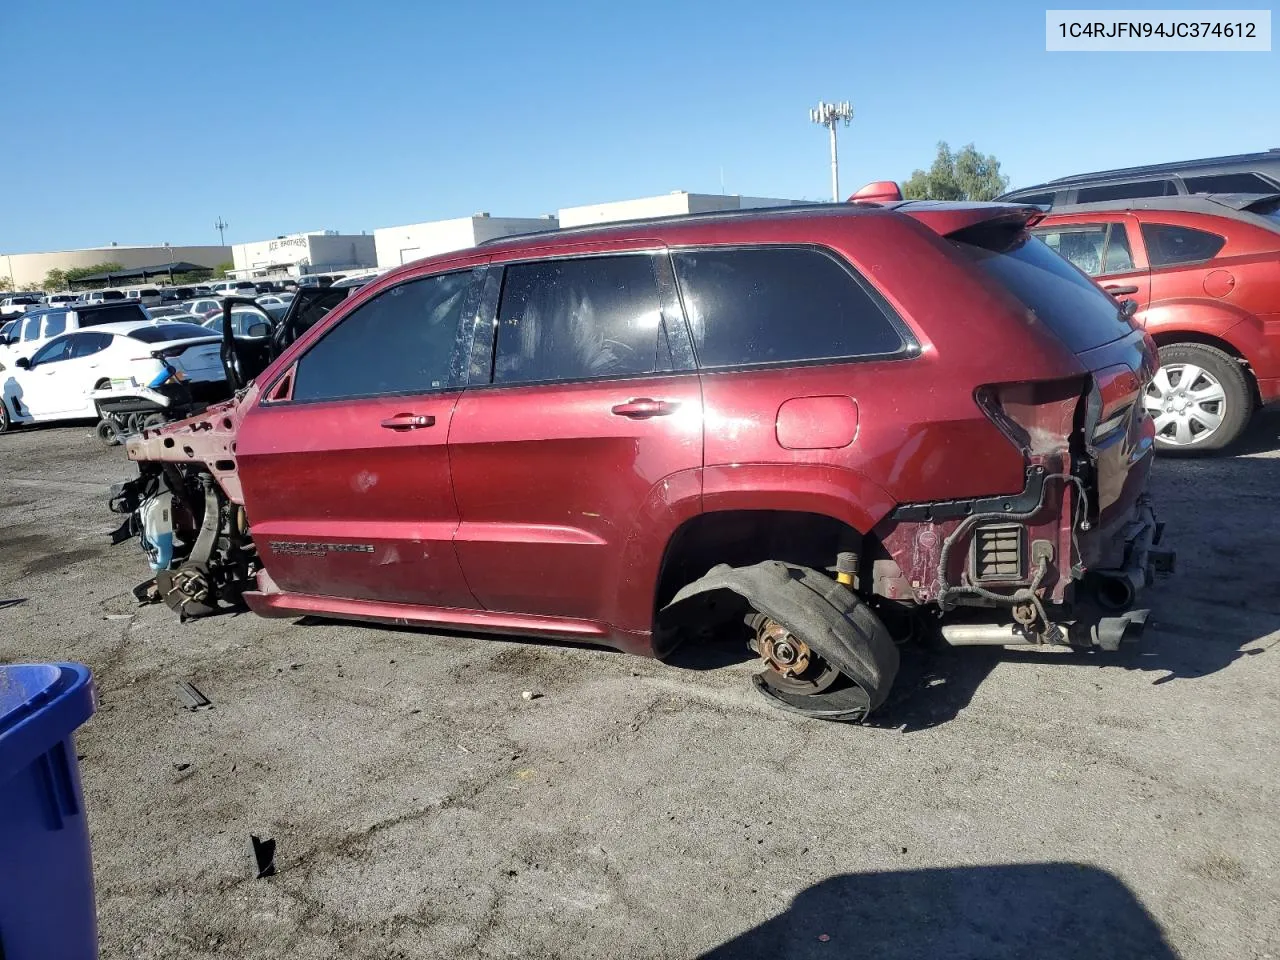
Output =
[{"x1": 0, "y1": 663, "x2": 97, "y2": 960}]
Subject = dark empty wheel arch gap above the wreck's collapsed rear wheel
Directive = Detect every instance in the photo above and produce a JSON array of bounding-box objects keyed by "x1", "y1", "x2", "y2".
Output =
[{"x1": 654, "y1": 509, "x2": 863, "y2": 631}]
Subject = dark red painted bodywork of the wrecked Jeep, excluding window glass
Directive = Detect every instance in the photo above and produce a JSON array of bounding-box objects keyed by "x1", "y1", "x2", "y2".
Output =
[{"x1": 129, "y1": 204, "x2": 1155, "y2": 652}]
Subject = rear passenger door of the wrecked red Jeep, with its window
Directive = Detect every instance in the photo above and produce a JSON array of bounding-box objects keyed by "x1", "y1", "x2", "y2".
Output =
[{"x1": 449, "y1": 250, "x2": 703, "y2": 634}]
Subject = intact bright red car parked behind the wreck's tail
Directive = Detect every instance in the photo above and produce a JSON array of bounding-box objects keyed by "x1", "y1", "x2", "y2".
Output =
[{"x1": 1032, "y1": 195, "x2": 1280, "y2": 452}]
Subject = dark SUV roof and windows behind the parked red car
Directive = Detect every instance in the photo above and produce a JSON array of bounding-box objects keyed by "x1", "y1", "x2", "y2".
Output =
[{"x1": 997, "y1": 150, "x2": 1280, "y2": 207}]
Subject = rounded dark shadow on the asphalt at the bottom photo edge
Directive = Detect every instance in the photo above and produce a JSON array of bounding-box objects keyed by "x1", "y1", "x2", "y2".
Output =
[{"x1": 703, "y1": 863, "x2": 1176, "y2": 960}]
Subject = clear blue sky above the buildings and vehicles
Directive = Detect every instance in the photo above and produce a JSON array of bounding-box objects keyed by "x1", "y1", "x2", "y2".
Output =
[{"x1": 0, "y1": 0, "x2": 1280, "y2": 252}]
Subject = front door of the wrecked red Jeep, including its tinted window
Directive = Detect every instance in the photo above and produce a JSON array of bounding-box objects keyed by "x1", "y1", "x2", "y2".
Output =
[{"x1": 236, "y1": 270, "x2": 476, "y2": 607}]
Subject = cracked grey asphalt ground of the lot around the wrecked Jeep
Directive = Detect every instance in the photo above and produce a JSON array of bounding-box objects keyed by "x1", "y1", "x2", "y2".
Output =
[{"x1": 0, "y1": 415, "x2": 1280, "y2": 960}]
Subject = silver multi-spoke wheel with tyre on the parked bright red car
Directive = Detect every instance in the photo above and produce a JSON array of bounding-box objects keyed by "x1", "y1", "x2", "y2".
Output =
[{"x1": 1143, "y1": 343, "x2": 1253, "y2": 453}]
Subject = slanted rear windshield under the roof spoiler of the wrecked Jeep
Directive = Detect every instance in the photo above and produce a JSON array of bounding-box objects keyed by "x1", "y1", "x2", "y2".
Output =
[{"x1": 955, "y1": 230, "x2": 1134, "y2": 353}]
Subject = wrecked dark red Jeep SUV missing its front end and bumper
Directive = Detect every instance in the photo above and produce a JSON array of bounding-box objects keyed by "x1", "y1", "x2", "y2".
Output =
[{"x1": 113, "y1": 202, "x2": 1171, "y2": 719}]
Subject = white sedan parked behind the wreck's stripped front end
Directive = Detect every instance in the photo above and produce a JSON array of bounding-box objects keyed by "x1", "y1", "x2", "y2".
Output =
[{"x1": 0, "y1": 320, "x2": 225, "y2": 433}]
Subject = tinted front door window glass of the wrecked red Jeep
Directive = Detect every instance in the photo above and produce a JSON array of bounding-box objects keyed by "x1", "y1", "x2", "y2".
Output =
[{"x1": 293, "y1": 270, "x2": 471, "y2": 401}]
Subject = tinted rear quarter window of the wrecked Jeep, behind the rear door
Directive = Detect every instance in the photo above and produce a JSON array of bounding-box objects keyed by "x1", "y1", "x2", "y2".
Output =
[{"x1": 673, "y1": 247, "x2": 904, "y2": 367}]
